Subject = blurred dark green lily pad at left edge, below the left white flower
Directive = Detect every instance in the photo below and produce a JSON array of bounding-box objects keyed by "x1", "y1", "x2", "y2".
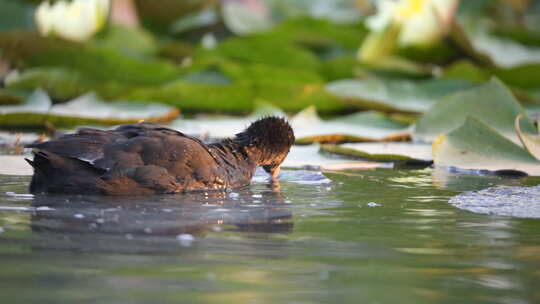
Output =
[{"x1": 0, "y1": 31, "x2": 183, "y2": 85}]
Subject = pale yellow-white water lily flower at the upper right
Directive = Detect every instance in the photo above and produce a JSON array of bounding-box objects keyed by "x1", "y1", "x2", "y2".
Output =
[{"x1": 366, "y1": 0, "x2": 459, "y2": 46}]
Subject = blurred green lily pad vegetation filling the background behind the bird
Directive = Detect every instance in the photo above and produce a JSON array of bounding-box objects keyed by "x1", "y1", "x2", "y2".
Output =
[{"x1": 0, "y1": 0, "x2": 540, "y2": 173}]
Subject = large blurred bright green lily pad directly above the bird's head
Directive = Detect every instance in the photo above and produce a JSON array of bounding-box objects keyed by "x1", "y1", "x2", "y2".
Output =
[{"x1": 121, "y1": 62, "x2": 346, "y2": 113}]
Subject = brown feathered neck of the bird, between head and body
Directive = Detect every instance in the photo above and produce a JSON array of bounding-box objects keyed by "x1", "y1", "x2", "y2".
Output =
[{"x1": 208, "y1": 139, "x2": 257, "y2": 187}]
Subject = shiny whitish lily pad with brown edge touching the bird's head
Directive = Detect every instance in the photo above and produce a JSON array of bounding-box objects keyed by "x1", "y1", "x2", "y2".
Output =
[{"x1": 290, "y1": 107, "x2": 411, "y2": 144}]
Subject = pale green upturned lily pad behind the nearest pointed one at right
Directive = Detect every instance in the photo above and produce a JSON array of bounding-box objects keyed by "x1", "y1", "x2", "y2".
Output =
[{"x1": 413, "y1": 79, "x2": 535, "y2": 143}]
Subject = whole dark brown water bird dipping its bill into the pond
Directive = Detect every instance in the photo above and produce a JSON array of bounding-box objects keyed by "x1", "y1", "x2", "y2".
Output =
[{"x1": 26, "y1": 116, "x2": 295, "y2": 195}]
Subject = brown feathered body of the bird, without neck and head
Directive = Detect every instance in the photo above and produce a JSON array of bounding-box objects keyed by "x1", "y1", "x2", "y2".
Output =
[{"x1": 26, "y1": 123, "x2": 242, "y2": 195}]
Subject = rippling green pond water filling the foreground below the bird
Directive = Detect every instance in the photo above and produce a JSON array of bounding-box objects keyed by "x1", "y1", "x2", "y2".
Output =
[{"x1": 0, "y1": 169, "x2": 540, "y2": 303}]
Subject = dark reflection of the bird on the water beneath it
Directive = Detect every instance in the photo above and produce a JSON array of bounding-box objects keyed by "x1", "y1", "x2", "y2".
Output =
[{"x1": 31, "y1": 183, "x2": 293, "y2": 251}]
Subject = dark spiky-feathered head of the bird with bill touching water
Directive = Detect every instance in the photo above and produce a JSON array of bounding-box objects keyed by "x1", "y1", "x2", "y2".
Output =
[{"x1": 234, "y1": 116, "x2": 294, "y2": 179}]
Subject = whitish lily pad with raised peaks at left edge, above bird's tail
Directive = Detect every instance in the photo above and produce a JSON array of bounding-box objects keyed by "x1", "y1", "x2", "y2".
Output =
[{"x1": 0, "y1": 90, "x2": 179, "y2": 127}]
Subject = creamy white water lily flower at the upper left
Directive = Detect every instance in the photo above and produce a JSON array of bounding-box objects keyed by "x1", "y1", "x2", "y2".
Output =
[{"x1": 35, "y1": 0, "x2": 110, "y2": 41}]
